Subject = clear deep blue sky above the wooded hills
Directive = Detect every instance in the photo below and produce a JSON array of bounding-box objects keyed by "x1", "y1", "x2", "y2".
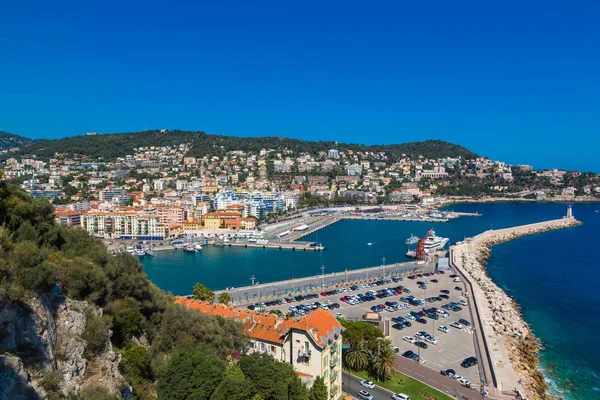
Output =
[{"x1": 0, "y1": 0, "x2": 600, "y2": 171}]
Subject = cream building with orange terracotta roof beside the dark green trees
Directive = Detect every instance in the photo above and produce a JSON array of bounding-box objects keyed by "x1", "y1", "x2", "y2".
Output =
[{"x1": 175, "y1": 297, "x2": 342, "y2": 399}]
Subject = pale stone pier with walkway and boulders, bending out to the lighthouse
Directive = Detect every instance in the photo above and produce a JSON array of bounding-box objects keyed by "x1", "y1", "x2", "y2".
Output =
[{"x1": 450, "y1": 212, "x2": 580, "y2": 397}]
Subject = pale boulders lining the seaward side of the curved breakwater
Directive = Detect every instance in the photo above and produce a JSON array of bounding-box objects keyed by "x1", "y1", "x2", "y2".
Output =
[{"x1": 452, "y1": 218, "x2": 580, "y2": 399}]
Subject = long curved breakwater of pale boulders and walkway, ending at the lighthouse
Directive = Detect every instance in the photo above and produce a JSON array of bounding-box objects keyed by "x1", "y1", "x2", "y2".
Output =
[{"x1": 451, "y1": 217, "x2": 581, "y2": 399}]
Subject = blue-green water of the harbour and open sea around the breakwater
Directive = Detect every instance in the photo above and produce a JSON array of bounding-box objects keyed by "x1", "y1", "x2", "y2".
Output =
[{"x1": 142, "y1": 203, "x2": 600, "y2": 399}]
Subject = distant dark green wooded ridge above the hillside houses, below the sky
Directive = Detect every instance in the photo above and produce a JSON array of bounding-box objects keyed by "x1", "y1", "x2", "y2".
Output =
[{"x1": 7, "y1": 130, "x2": 475, "y2": 160}]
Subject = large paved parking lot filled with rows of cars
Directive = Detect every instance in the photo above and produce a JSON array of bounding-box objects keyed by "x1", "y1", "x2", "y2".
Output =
[{"x1": 246, "y1": 270, "x2": 480, "y2": 387}]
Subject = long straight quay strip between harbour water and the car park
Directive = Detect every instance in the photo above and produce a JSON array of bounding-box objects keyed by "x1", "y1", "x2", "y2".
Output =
[{"x1": 215, "y1": 258, "x2": 435, "y2": 306}]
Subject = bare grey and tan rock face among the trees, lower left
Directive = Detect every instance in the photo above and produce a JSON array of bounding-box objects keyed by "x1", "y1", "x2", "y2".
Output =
[{"x1": 0, "y1": 285, "x2": 124, "y2": 400}]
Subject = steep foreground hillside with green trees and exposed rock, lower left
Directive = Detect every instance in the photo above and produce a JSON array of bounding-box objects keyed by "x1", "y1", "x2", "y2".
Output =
[{"x1": 0, "y1": 181, "x2": 320, "y2": 400}]
